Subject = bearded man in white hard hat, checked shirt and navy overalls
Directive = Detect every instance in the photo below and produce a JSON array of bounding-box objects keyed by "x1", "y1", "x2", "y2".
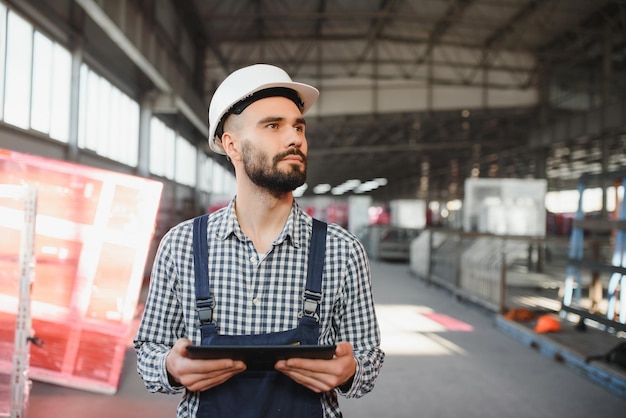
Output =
[{"x1": 135, "y1": 64, "x2": 384, "y2": 418}]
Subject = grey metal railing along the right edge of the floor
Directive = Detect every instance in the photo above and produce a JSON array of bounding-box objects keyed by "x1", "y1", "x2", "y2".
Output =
[{"x1": 410, "y1": 228, "x2": 568, "y2": 313}]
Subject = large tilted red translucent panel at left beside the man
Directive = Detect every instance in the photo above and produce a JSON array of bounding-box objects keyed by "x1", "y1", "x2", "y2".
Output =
[{"x1": 0, "y1": 150, "x2": 162, "y2": 394}]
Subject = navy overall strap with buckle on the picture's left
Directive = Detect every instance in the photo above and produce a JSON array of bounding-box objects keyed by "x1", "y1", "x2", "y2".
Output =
[{"x1": 193, "y1": 215, "x2": 215, "y2": 326}]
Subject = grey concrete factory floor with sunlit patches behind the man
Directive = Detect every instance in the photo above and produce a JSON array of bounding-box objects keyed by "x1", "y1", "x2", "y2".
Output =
[{"x1": 20, "y1": 261, "x2": 626, "y2": 418}]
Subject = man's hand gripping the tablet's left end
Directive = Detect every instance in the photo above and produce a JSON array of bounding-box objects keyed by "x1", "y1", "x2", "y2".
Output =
[{"x1": 165, "y1": 338, "x2": 246, "y2": 392}]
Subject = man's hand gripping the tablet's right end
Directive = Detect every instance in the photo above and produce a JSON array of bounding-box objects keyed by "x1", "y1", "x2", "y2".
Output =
[{"x1": 275, "y1": 342, "x2": 356, "y2": 393}]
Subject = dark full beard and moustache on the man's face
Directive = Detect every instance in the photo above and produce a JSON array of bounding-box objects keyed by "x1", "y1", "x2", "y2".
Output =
[{"x1": 243, "y1": 145, "x2": 306, "y2": 195}]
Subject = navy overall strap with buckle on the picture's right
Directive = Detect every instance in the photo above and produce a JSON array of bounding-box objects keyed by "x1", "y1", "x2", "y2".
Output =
[{"x1": 303, "y1": 218, "x2": 328, "y2": 321}]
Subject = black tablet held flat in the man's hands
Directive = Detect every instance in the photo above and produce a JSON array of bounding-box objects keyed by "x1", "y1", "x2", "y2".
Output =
[{"x1": 187, "y1": 345, "x2": 336, "y2": 370}]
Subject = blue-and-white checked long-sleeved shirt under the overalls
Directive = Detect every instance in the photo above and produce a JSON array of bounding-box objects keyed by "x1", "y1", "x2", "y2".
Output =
[{"x1": 134, "y1": 200, "x2": 384, "y2": 418}]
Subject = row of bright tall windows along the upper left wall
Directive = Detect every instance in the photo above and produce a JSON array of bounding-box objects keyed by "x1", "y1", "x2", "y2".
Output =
[{"x1": 0, "y1": 0, "x2": 234, "y2": 193}]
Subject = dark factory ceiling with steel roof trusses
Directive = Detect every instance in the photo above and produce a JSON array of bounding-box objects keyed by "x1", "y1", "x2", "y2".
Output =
[{"x1": 14, "y1": 0, "x2": 626, "y2": 199}]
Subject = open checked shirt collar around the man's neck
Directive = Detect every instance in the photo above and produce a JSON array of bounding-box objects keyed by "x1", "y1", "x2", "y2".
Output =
[{"x1": 217, "y1": 199, "x2": 310, "y2": 248}]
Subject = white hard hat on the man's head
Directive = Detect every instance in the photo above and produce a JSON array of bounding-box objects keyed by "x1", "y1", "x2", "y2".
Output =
[{"x1": 209, "y1": 64, "x2": 319, "y2": 154}]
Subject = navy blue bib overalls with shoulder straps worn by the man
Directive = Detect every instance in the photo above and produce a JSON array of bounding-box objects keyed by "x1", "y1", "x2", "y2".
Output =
[{"x1": 193, "y1": 215, "x2": 327, "y2": 418}]
